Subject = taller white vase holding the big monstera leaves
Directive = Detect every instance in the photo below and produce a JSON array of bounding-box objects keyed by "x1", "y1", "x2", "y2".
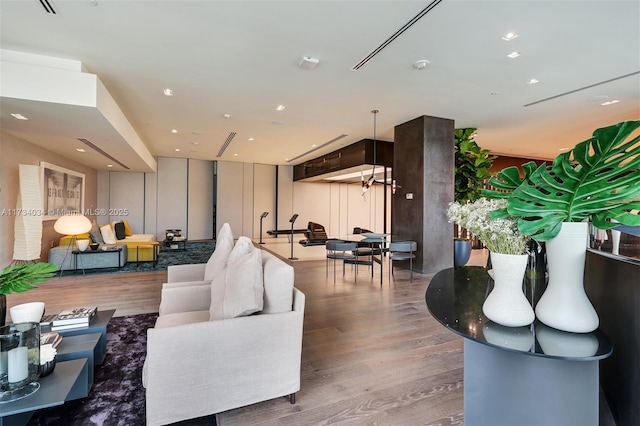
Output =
[{"x1": 536, "y1": 222, "x2": 600, "y2": 333}]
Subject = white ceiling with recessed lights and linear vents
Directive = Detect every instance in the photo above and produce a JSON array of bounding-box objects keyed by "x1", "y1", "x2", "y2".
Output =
[{"x1": 0, "y1": 0, "x2": 640, "y2": 171}]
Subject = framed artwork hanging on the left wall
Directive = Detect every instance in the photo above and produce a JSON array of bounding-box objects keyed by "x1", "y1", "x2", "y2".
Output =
[{"x1": 40, "y1": 161, "x2": 84, "y2": 220}]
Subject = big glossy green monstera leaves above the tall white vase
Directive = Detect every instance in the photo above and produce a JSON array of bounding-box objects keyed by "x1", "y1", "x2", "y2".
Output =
[{"x1": 482, "y1": 120, "x2": 640, "y2": 241}]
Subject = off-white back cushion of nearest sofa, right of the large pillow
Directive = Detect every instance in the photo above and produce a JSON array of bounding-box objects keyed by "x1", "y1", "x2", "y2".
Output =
[{"x1": 262, "y1": 251, "x2": 294, "y2": 314}]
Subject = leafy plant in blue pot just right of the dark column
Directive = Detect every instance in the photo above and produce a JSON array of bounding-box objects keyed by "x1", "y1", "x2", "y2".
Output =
[{"x1": 453, "y1": 127, "x2": 496, "y2": 266}]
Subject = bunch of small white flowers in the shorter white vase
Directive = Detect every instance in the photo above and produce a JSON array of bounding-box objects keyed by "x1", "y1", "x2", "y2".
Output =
[{"x1": 447, "y1": 198, "x2": 529, "y2": 254}]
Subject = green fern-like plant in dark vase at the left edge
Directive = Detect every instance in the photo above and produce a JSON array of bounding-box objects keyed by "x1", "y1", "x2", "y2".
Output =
[{"x1": 0, "y1": 262, "x2": 58, "y2": 326}]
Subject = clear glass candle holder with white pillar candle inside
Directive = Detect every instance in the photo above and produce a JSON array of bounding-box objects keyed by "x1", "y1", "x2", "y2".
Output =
[{"x1": 0, "y1": 322, "x2": 40, "y2": 403}]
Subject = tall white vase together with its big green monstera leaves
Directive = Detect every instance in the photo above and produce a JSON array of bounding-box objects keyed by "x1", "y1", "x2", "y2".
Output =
[{"x1": 483, "y1": 121, "x2": 640, "y2": 333}]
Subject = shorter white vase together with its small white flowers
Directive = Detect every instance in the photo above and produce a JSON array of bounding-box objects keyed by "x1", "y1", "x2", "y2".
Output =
[{"x1": 447, "y1": 198, "x2": 535, "y2": 327}]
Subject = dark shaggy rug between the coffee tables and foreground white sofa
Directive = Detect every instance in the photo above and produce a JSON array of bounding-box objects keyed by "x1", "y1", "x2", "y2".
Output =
[{"x1": 28, "y1": 314, "x2": 215, "y2": 426}]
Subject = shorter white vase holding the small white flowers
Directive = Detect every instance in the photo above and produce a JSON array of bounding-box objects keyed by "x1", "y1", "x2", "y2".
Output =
[{"x1": 482, "y1": 252, "x2": 535, "y2": 327}]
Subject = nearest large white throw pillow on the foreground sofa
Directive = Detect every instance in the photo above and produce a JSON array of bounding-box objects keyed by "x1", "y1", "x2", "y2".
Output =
[{"x1": 209, "y1": 237, "x2": 264, "y2": 320}]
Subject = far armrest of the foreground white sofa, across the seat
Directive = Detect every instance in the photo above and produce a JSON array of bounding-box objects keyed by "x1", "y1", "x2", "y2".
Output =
[{"x1": 159, "y1": 283, "x2": 211, "y2": 315}]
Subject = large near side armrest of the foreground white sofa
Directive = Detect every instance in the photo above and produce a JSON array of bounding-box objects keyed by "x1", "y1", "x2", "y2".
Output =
[{"x1": 143, "y1": 289, "x2": 305, "y2": 424}]
